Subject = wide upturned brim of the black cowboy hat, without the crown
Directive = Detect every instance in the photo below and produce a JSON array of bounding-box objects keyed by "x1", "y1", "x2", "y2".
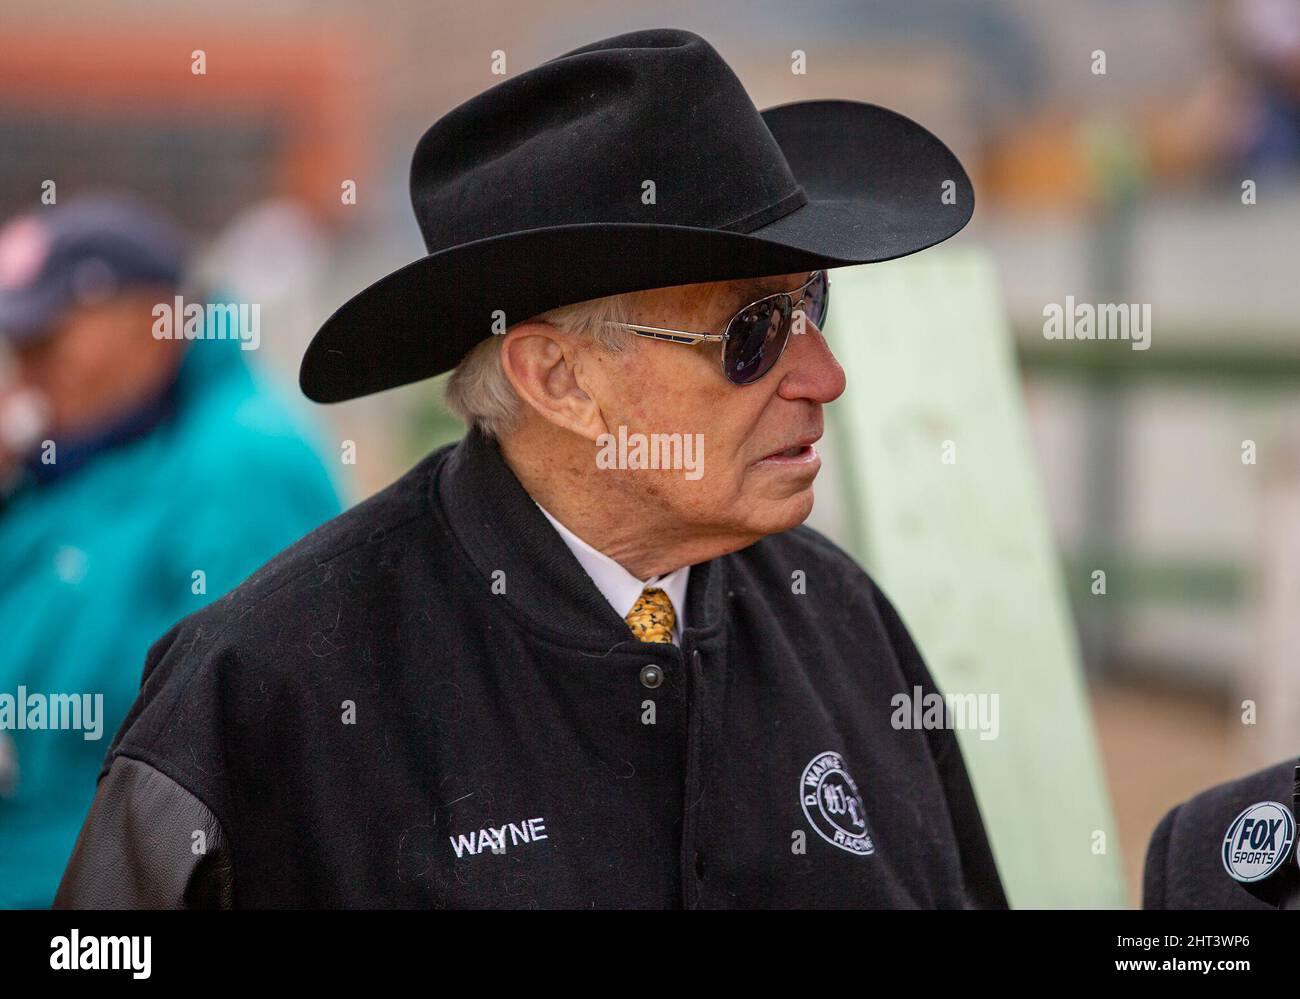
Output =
[{"x1": 299, "y1": 100, "x2": 975, "y2": 402}]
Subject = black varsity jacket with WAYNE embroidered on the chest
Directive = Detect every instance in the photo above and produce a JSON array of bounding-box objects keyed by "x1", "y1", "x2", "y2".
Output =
[{"x1": 56, "y1": 433, "x2": 1006, "y2": 908}]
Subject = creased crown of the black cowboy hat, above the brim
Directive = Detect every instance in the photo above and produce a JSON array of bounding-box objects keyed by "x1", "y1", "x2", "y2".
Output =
[{"x1": 411, "y1": 31, "x2": 807, "y2": 252}]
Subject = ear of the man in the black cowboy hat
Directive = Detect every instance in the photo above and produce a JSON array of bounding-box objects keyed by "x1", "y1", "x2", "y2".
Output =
[{"x1": 501, "y1": 323, "x2": 607, "y2": 442}]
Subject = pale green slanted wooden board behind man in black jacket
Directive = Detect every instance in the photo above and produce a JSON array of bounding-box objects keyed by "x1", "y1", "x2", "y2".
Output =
[{"x1": 827, "y1": 247, "x2": 1130, "y2": 908}]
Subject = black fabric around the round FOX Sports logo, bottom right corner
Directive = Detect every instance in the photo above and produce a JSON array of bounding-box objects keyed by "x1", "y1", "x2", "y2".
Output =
[{"x1": 1143, "y1": 758, "x2": 1300, "y2": 909}]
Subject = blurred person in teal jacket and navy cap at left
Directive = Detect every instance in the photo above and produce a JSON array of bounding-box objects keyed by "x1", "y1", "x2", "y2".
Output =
[{"x1": 0, "y1": 195, "x2": 341, "y2": 907}]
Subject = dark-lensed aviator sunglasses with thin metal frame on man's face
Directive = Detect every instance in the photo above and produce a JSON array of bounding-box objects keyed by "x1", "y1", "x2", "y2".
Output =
[{"x1": 606, "y1": 271, "x2": 831, "y2": 385}]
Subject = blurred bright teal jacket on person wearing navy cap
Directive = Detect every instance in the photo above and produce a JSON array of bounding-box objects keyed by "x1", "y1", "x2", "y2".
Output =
[{"x1": 0, "y1": 341, "x2": 339, "y2": 908}]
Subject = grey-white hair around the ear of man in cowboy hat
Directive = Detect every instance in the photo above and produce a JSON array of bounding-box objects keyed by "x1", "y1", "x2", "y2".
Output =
[{"x1": 442, "y1": 293, "x2": 636, "y2": 437}]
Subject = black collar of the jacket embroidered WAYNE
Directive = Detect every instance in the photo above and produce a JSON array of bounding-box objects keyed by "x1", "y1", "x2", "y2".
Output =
[{"x1": 433, "y1": 429, "x2": 724, "y2": 652}]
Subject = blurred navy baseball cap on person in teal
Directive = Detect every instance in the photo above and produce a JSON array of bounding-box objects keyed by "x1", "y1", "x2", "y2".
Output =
[{"x1": 0, "y1": 194, "x2": 190, "y2": 342}]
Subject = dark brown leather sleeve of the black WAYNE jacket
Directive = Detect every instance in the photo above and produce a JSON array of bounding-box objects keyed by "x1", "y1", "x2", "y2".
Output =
[{"x1": 55, "y1": 756, "x2": 234, "y2": 909}]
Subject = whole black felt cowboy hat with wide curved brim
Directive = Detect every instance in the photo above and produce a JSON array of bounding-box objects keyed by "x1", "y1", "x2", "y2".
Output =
[{"x1": 299, "y1": 29, "x2": 975, "y2": 402}]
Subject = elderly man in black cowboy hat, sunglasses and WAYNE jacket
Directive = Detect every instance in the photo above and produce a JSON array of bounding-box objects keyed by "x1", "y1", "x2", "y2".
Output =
[{"x1": 59, "y1": 30, "x2": 1006, "y2": 908}]
